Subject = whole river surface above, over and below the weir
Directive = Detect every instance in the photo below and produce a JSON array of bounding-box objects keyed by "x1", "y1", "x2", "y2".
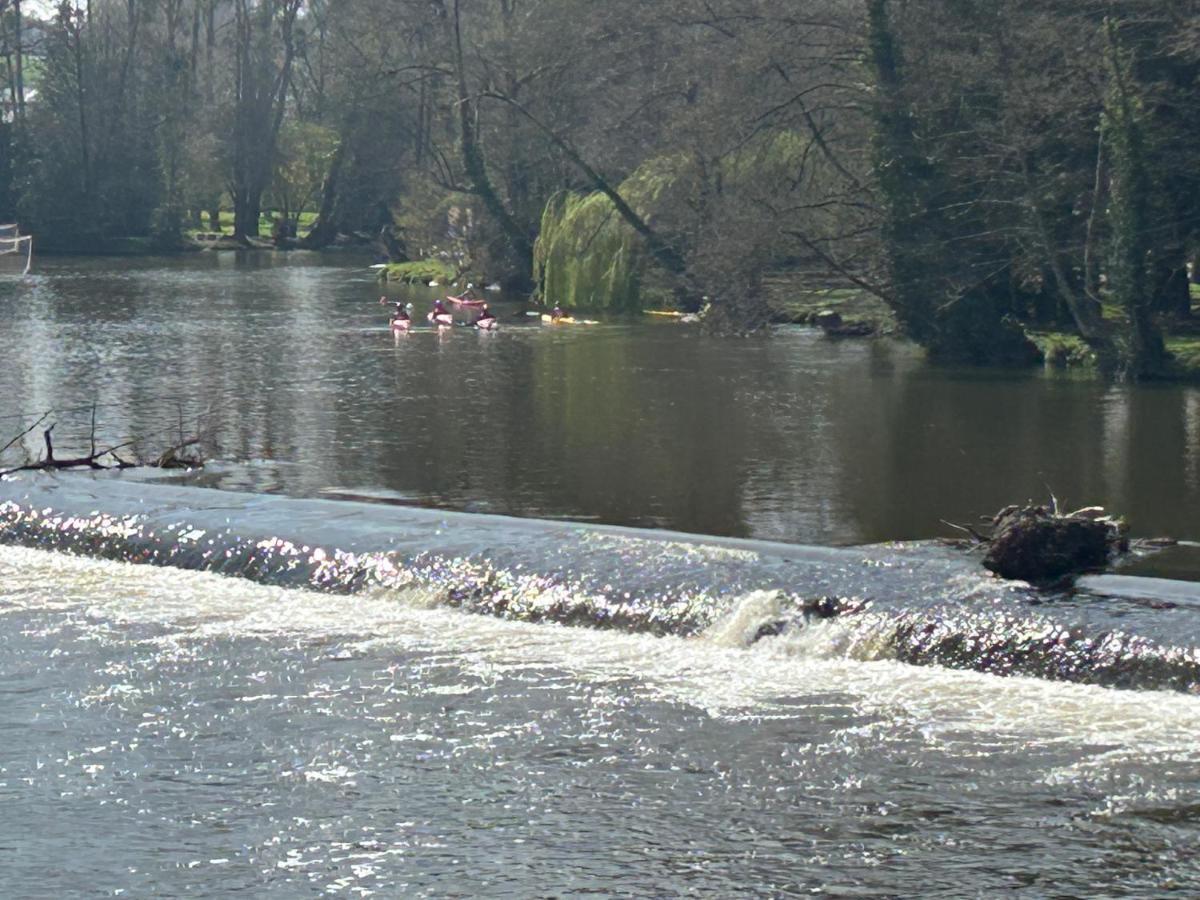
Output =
[{"x1": 0, "y1": 254, "x2": 1200, "y2": 898}]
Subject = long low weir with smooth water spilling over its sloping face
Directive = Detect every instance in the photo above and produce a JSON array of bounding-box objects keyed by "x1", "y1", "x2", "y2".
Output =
[{"x1": 0, "y1": 473, "x2": 1200, "y2": 692}]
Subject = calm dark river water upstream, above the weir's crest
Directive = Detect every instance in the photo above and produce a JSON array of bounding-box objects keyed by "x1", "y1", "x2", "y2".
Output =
[{"x1": 0, "y1": 253, "x2": 1200, "y2": 549}]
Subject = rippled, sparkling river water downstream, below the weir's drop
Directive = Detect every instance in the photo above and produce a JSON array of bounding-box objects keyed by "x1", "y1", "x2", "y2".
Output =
[{"x1": 7, "y1": 547, "x2": 1200, "y2": 898}]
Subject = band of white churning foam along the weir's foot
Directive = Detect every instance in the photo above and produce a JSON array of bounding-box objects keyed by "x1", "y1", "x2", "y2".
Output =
[{"x1": 9, "y1": 547, "x2": 1200, "y2": 770}]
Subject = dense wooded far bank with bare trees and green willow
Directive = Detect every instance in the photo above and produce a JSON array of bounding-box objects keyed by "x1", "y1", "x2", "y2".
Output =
[{"x1": 0, "y1": 0, "x2": 1200, "y2": 377}]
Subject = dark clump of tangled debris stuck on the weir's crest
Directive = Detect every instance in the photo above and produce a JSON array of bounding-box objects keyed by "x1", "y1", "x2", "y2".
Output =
[{"x1": 983, "y1": 506, "x2": 1128, "y2": 582}]
